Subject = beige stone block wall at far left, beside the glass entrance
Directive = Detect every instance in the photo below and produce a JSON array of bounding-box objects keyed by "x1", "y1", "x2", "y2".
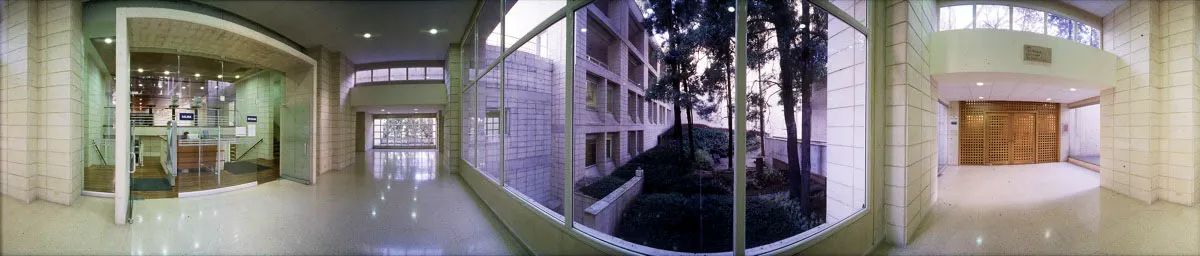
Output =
[{"x1": 0, "y1": 0, "x2": 84, "y2": 204}]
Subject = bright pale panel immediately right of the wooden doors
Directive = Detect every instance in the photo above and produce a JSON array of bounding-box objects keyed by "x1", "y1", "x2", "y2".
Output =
[{"x1": 1066, "y1": 105, "x2": 1100, "y2": 165}]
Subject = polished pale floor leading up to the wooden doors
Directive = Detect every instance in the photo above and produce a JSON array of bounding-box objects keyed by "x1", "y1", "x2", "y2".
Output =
[{"x1": 876, "y1": 162, "x2": 1200, "y2": 255}]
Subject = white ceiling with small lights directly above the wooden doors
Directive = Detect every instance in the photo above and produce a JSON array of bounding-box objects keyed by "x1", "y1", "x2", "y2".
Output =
[{"x1": 934, "y1": 72, "x2": 1105, "y2": 103}]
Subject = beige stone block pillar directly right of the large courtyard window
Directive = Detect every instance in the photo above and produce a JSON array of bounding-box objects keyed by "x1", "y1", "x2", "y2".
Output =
[{"x1": 882, "y1": 1, "x2": 937, "y2": 246}]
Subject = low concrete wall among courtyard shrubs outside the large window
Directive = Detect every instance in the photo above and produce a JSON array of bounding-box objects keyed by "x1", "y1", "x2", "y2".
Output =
[{"x1": 572, "y1": 169, "x2": 643, "y2": 234}]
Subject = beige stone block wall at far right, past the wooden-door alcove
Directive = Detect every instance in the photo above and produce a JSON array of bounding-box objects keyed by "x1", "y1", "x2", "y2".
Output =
[{"x1": 1100, "y1": 1, "x2": 1200, "y2": 204}]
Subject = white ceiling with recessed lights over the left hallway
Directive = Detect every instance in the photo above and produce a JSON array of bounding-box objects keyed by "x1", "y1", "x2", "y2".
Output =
[{"x1": 198, "y1": 0, "x2": 475, "y2": 64}]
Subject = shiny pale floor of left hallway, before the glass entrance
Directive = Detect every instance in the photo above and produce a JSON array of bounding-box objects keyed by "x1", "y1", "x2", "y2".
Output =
[{"x1": 0, "y1": 150, "x2": 524, "y2": 255}]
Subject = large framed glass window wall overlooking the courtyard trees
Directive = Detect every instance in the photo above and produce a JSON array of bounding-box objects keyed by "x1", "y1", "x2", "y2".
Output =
[{"x1": 456, "y1": 0, "x2": 872, "y2": 255}]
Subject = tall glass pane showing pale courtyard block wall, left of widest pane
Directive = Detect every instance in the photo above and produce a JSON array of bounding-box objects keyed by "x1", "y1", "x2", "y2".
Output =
[{"x1": 504, "y1": 16, "x2": 569, "y2": 214}]
